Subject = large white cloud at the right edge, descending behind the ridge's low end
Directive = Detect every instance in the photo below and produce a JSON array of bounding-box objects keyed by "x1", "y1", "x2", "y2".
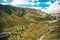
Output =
[{"x1": 44, "y1": 0, "x2": 60, "y2": 13}]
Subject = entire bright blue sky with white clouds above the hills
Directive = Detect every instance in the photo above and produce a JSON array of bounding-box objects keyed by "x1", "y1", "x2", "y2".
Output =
[{"x1": 0, "y1": 0, "x2": 60, "y2": 13}]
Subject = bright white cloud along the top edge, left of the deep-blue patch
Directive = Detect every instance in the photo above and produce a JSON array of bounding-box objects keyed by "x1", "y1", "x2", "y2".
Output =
[{"x1": 10, "y1": 0, "x2": 40, "y2": 6}]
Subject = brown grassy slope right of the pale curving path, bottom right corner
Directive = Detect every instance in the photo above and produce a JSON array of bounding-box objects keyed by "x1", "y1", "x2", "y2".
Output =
[{"x1": 44, "y1": 20, "x2": 60, "y2": 40}]
